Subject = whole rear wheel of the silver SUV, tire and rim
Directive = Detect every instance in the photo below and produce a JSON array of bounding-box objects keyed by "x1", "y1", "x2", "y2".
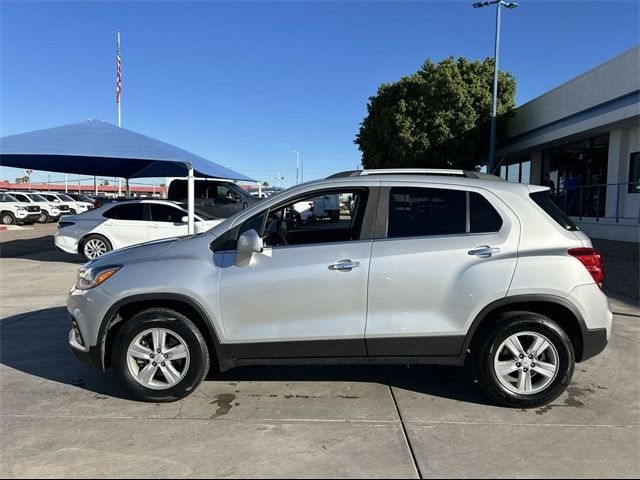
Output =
[{"x1": 471, "y1": 312, "x2": 575, "y2": 408}]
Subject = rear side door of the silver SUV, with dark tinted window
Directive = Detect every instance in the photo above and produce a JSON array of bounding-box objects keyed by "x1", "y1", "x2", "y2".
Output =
[{"x1": 366, "y1": 183, "x2": 520, "y2": 356}]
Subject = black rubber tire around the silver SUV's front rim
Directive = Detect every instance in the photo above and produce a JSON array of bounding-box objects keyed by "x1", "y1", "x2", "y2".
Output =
[{"x1": 111, "y1": 308, "x2": 211, "y2": 402}]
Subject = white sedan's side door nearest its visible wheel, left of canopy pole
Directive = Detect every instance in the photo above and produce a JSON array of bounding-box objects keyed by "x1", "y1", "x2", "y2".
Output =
[{"x1": 99, "y1": 203, "x2": 149, "y2": 249}]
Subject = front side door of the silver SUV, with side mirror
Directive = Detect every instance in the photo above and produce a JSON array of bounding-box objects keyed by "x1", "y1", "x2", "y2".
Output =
[{"x1": 219, "y1": 188, "x2": 378, "y2": 358}]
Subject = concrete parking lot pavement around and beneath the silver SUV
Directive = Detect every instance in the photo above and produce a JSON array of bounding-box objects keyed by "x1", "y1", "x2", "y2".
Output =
[{"x1": 0, "y1": 225, "x2": 640, "y2": 478}]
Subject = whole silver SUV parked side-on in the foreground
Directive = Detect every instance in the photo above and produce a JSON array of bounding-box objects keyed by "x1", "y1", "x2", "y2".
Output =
[{"x1": 67, "y1": 170, "x2": 612, "y2": 407}]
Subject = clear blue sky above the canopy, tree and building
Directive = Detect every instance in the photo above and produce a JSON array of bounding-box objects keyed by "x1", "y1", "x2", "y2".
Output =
[{"x1": 0, "y1": 0, "x2": 640, "y2": 186}]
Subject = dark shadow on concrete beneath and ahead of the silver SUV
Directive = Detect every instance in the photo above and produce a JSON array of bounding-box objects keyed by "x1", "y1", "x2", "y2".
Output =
[{"x1": 0, "y1": 307, "x2": 489, "y2": 404}]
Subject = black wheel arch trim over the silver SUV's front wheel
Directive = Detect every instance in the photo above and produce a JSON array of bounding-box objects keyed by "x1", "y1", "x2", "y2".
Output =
[{"x1": 98, "y1": 292, "x2": 235, "y2": 371}]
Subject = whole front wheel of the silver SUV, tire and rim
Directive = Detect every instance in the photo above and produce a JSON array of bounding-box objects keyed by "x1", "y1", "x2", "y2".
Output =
[{"x1": 111, "y1": 308, "x2": 210, "y2": 402}]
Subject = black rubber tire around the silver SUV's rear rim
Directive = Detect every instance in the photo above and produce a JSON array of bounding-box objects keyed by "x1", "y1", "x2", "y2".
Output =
[{"x1": 470, "y1": 312, "x2": 575, "y2": 408}]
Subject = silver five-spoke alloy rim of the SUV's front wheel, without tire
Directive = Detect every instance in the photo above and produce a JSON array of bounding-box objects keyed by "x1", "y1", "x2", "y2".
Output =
[{"x1": 127, "y1": 328, "x2": 191, "y2": 390}]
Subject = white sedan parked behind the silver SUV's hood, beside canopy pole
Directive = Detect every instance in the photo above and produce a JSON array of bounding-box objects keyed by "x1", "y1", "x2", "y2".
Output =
[{"x1": 55, "y1": 200, "x2": 224, "y2": 261}]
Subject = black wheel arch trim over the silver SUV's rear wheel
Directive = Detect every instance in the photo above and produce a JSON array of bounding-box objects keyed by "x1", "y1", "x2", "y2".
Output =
[{"x1": 462, "y1": 294, "x2": 587, "y2": 362}]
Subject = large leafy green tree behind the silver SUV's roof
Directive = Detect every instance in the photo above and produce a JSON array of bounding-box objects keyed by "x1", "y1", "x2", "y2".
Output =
[{"x1": 355, "y1": 57, "x2": 516, "y2": 170}]
